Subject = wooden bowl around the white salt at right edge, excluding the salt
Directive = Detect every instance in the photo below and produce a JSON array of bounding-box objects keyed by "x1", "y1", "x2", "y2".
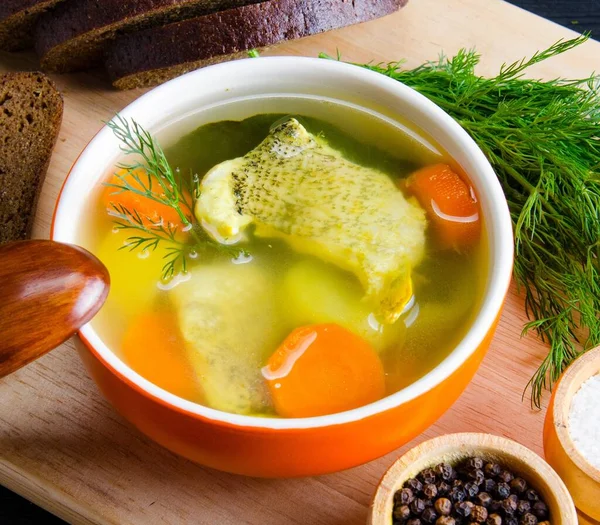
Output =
[{"x1": 544, "y1": 347, "x2": 600, "y2": 523}]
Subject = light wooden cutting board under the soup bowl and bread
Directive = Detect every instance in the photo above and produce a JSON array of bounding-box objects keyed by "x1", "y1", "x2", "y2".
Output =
[{"x1": 0, "y1": 0, "x2": 600, "y2": 525}]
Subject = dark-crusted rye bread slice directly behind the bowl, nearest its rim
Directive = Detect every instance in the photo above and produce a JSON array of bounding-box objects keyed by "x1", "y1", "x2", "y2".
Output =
[{"x1": 105, "y1": 0, "x2": 407, "y2": 89}]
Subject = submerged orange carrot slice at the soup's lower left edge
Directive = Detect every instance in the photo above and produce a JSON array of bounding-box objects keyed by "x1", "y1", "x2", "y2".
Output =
[{"x1": 121, "y1": 312, "x2": 201, "y2": 401}]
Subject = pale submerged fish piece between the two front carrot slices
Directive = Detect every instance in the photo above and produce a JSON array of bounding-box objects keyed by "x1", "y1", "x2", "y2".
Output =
[{"x1": 169, "y1": 261, "x2": 284, "y2": 414}]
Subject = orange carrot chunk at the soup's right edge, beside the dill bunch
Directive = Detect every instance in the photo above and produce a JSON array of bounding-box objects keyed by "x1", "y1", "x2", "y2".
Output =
[{"x1": 404, "y1": 164, "x2": 481, "y2": 251}]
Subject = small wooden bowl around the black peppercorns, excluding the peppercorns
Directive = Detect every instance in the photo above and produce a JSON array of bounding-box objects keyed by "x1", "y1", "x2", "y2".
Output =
[{"x1": 368, "y1": 433, "x2": 577, "y2": 525}]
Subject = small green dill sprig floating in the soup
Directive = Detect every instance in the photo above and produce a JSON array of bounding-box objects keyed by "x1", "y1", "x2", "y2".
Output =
[{"x1": 105, "y1": 115, "x2": 245, "y2": 280}]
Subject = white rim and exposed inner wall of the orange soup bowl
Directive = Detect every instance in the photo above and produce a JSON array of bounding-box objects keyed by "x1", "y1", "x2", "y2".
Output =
[{"x1": 51, "y1": 57, "x2": 513, "y2": 428}]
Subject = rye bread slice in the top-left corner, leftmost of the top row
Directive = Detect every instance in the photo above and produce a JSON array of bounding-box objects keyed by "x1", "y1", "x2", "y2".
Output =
[{"x1": 0, "y1": 0, "x2": 63, "y2": 51}]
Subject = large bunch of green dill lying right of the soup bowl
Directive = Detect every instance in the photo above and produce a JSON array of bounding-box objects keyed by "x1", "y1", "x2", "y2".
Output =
[{"x1": 332, "y1": 35, "x2": 600, "y2": 407}]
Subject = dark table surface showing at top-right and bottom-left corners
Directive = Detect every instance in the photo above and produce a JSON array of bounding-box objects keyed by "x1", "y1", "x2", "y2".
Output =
[{"x1": 0, "y1": 0, "x2": 600, "y2": 525}]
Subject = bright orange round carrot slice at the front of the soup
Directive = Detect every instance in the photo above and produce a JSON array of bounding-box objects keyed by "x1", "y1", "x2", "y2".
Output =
[{"x1": 262, "y1": 324, "x2": 385, "y2": 417}]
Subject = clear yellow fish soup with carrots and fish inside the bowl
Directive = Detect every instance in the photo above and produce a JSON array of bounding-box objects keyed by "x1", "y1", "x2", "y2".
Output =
[{"x1": 81, "y1": 99, "x2": 486, "y2": 417}]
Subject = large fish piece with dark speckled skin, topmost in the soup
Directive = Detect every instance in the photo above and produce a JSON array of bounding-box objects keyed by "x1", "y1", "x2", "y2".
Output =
[{"x1": 195, "y1": 118, "x2": 426, "y2": 323}]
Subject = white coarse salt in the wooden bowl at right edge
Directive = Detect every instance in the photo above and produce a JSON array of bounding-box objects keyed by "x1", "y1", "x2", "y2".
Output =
[{"x1": 569, "y1": 374, "x2": 600, "y2": 468}]
